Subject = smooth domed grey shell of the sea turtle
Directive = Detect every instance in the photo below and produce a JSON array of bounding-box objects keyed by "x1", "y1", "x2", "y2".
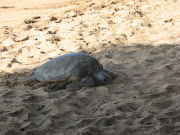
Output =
[{"x1": 35, "y1": 53, "x2": 102, "y2": 81}]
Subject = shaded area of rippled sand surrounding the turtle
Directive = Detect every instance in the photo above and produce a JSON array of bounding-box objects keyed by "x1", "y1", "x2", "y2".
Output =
[{"x1": 0, "y1": 45, "x2": 180, "y2": 135}]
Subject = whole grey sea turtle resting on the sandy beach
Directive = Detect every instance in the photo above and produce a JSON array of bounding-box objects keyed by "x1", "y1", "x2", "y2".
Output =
[{"x1": 33, "y1": 53, "x2": 117, "y2": 88}]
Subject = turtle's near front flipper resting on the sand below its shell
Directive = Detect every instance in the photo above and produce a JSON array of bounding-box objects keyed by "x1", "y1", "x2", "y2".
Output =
[{"x1": 66, "y1": 76, "x2": 95, "y2": 89}]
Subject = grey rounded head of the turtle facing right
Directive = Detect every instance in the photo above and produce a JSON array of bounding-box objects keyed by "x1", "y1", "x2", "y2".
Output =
[{"x1": 95, "y1": 71, "x2": 112, "y2": 85}]
